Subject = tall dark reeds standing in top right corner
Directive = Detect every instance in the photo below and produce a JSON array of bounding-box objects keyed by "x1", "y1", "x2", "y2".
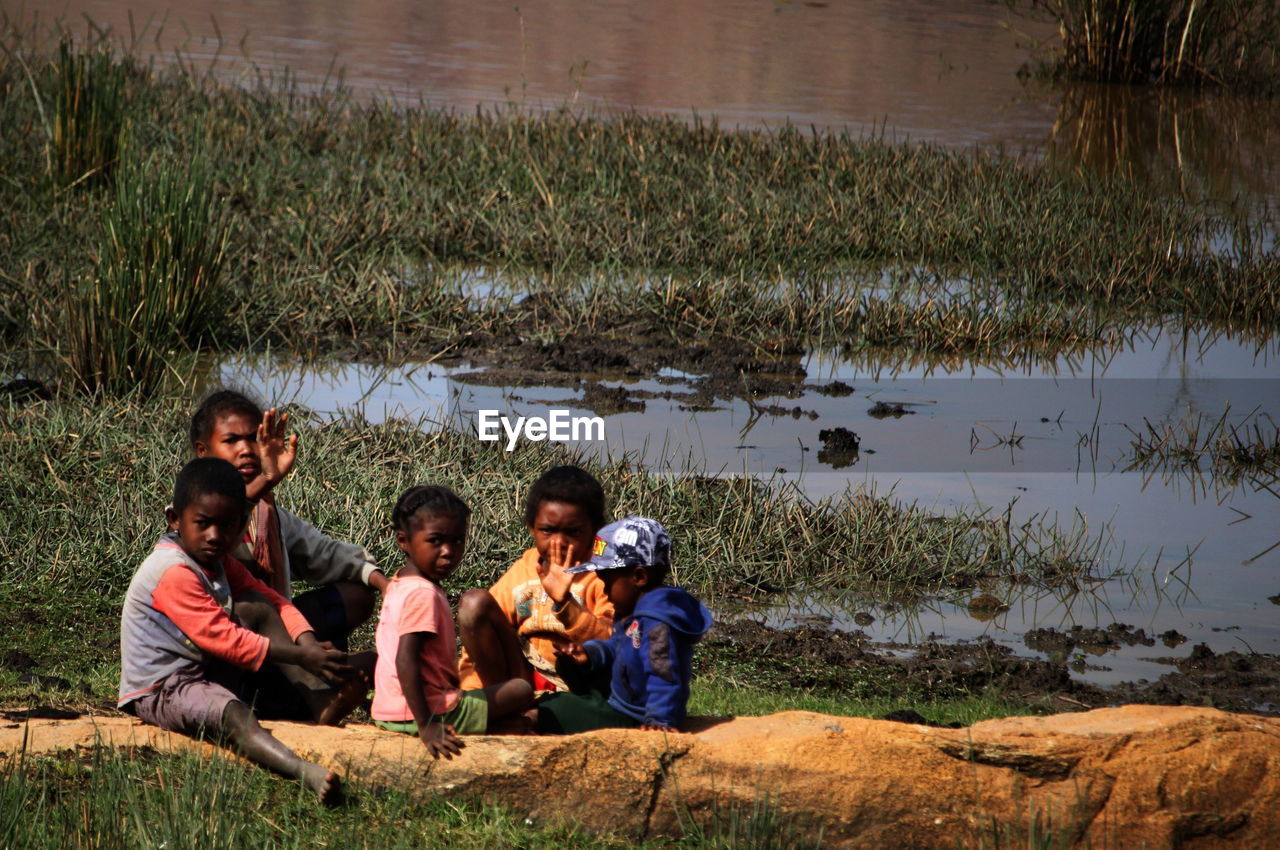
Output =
[{"x1": 1011, "y1": 0, "x2": 1280, "y2": 92}]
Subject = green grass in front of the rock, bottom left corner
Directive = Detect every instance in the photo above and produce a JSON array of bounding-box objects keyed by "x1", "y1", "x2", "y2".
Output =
[{"x1": 0, "y1": 748, "x2": 640, "y2": 850}]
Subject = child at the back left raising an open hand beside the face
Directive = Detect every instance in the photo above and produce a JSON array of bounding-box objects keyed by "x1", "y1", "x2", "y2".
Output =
[{"x1": 189, "y1": 389, "x2": 387, "y2": 650}]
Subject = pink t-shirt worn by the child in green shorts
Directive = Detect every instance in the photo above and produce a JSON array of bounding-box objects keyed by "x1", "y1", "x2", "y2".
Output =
[{"x1": 370, "y1": 576, "x2": 462, "y2": 722}]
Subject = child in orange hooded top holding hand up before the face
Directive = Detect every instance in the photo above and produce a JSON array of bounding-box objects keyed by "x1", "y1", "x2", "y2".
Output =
[{"x1": 458, "y1": 466, "x2": 613, "y2": 690}]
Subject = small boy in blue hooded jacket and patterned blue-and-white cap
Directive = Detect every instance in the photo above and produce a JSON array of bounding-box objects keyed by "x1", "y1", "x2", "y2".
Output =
[{"x1": 538, "y1": 516, "x2": 712, "y2": 734}]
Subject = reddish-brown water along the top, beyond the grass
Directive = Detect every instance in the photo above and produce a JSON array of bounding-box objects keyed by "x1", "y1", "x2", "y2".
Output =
[{"x1": 35, "y1": 0, "x2": 1280, "y2": 202}]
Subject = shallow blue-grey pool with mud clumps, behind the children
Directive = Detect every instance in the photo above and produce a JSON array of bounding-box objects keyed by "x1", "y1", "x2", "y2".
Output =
[{"x1": 223, "y1": 325, "x2": 1280, "y2": 685}]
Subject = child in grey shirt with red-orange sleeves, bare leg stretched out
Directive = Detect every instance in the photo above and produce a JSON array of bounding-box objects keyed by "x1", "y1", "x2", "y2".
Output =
[{"x1": 119, "y1": 457, "x2": 356, "y2": 804}]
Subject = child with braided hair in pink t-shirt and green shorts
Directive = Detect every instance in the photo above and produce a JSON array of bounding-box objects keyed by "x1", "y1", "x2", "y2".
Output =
[{"x1": 370, "y1": 486, "x2": 534, "y2": 758}]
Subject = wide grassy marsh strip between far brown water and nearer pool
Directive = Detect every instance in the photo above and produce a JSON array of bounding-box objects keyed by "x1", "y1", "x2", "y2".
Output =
[{"x1": 0, "y1": 33, "x2": 1280, "y2": 394}]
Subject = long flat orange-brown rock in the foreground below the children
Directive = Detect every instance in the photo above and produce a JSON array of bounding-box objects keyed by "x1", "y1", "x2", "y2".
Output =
[{"x1": 0, "y1": 705, "x2": 1280, "y2": 849}]
